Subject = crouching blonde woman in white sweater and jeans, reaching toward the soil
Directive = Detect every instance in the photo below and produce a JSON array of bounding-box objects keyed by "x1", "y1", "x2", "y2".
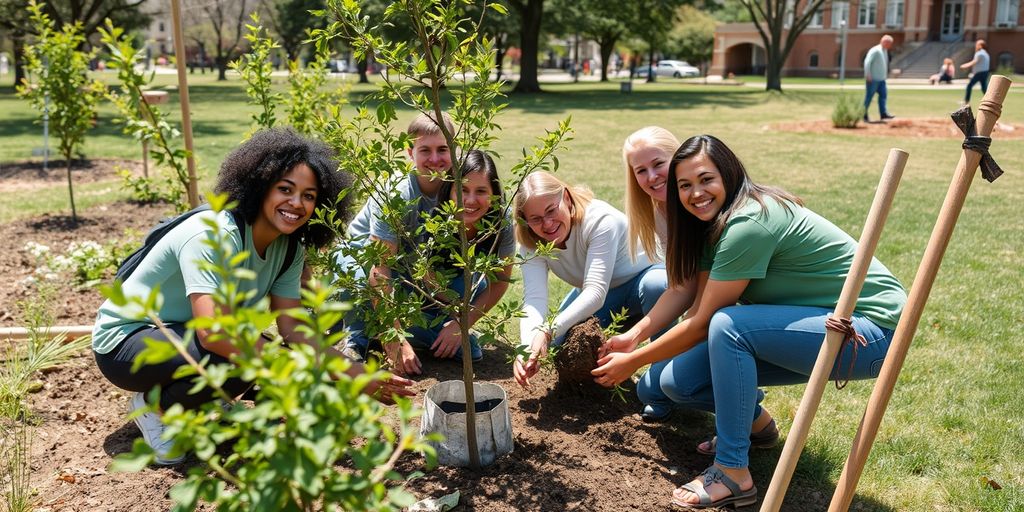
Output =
[{"x1": 512, "y1": 172, "x2": 668, "y2": 386}]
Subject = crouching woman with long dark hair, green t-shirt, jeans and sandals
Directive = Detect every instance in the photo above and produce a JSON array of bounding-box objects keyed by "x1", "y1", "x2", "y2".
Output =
[{"x1": 594, "y1": 135, "x2": 906, "y2": 509}]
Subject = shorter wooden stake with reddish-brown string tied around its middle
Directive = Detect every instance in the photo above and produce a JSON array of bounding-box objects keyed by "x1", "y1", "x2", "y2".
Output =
[{"x1": 761, "y1": 147, "x2": 908, "y2": 512}]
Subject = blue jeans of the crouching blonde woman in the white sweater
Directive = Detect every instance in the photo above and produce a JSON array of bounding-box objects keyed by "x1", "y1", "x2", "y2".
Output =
[{"x1": 551, "y1": 263, "x2": 672, "y2": 346}]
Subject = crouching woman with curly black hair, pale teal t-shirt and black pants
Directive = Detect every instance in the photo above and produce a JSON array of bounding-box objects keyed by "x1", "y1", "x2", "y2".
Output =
[{"x1": 92, "y1": 129, "x2": 413, "y2": 465}]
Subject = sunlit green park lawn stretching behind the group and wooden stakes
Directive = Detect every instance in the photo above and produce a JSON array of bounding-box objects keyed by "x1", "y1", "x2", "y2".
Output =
[{"x1": 0, "y1": 74, "x2": 1024, "y2": 511}]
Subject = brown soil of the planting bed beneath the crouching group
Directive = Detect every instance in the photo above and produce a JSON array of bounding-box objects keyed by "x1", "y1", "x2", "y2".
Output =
[{"x1": 0, "y1": 203, "x2": 886, "y2": 512}]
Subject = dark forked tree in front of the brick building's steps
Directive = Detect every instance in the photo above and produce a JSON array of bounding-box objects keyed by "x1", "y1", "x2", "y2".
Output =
[{"x1": 741, "y1": 0, "x2": 825, "y2": 92}]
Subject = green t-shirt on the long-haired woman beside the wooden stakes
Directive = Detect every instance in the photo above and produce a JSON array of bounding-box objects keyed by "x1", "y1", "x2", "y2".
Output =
[{"x1": 701, "y1": 198, "x2": 906, "y2": 329}]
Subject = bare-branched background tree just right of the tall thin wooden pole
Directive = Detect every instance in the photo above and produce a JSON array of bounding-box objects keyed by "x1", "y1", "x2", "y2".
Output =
[{"x1": 178, "y1": 0, "x2": 252, "y2": 80}]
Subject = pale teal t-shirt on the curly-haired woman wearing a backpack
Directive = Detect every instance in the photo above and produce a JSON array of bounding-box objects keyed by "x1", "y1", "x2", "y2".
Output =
[{"x1": 92, "y1": 211, "x2": 305, "y2": 353}]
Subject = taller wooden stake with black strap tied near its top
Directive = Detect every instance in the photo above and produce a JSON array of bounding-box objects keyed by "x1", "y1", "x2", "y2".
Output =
[{"x1": 828, "y1": 75, "x2": 1010, "y2": 512}]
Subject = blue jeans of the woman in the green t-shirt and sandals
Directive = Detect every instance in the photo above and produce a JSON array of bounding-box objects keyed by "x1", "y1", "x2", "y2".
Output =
[{"x1": 637, "y1": 304, "x2": 893, "y2": 468}]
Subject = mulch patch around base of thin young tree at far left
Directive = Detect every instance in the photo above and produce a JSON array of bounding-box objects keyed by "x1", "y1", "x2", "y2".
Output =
[{"x1": 0, "y1": 159, "x2": 142, "y2": 193}]
